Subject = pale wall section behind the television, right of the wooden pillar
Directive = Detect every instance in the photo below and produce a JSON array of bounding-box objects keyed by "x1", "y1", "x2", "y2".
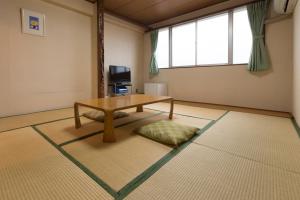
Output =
[{"x1": 104, "y1": 15, "x2": 144, "y2": 94}]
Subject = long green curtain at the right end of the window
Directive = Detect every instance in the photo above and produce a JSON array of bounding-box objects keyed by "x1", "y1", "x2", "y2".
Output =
[{"x1": 247, "y1": 0, "x2": 269, "y2": 72}]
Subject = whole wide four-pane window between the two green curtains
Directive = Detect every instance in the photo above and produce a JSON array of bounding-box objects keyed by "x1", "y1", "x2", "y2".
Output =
[{"x1": 156, "y1": 7, "x2": 252, "y2": 68}]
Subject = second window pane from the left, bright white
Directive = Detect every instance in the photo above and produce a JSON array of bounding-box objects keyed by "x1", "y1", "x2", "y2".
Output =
[{"x1": 172, "y1": 22, "x2": 196, "y2": 66}]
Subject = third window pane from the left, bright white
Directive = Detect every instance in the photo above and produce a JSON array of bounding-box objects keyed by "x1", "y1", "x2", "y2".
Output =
[{"x1": 197, "y1": 13, "x2": 228, "y2": 65}]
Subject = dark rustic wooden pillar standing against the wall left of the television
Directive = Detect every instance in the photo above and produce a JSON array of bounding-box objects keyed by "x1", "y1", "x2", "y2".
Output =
[{"x1": 97, "y1": 0, "x2": 105, "y2": 98}]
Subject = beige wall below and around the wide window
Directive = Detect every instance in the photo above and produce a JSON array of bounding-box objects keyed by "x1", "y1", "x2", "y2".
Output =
[{"x1": 144, "y1": 19, "x2": 293, "y2": 112}]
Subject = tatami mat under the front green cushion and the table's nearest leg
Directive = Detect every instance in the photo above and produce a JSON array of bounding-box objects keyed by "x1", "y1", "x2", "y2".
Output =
[{"x1": 63, "y1": 114, "x2": 208, "y2": 191}]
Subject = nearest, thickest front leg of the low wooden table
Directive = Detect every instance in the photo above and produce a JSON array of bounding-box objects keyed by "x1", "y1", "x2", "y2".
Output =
[{"x1": 103, "y1": 111, "x2": 116, "y2": 142}]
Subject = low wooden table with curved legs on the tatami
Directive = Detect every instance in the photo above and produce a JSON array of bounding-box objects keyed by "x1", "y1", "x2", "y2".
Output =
[{"x1": 74, "y1": 94, "x2": 174, "y2": 142}]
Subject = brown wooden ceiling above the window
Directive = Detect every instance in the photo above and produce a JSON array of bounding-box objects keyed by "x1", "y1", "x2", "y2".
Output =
[{"x1": 86, "y1": 0, "x2": 257, "y2": 30}]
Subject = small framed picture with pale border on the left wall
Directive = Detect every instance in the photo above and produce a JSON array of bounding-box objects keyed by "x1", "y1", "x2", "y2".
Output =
[{"x1": 21, "y1": 8, "x2": 45, "y2": 36}]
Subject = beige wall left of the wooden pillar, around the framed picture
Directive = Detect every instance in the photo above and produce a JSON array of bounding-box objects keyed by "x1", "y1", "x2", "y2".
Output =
[{"x1": 0, "y1": 0, "x2": 93, "y2": 116}]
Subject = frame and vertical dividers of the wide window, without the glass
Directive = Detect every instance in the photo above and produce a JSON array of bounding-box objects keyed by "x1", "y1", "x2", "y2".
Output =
[{"x1": 159, "y1": 6, "x2": 248, "y2": 69}]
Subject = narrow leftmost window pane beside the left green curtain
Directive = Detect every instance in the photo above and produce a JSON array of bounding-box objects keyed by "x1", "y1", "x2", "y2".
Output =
[{"x1": 155, "y1": 28, "x2": 169, "y2": 68}]
